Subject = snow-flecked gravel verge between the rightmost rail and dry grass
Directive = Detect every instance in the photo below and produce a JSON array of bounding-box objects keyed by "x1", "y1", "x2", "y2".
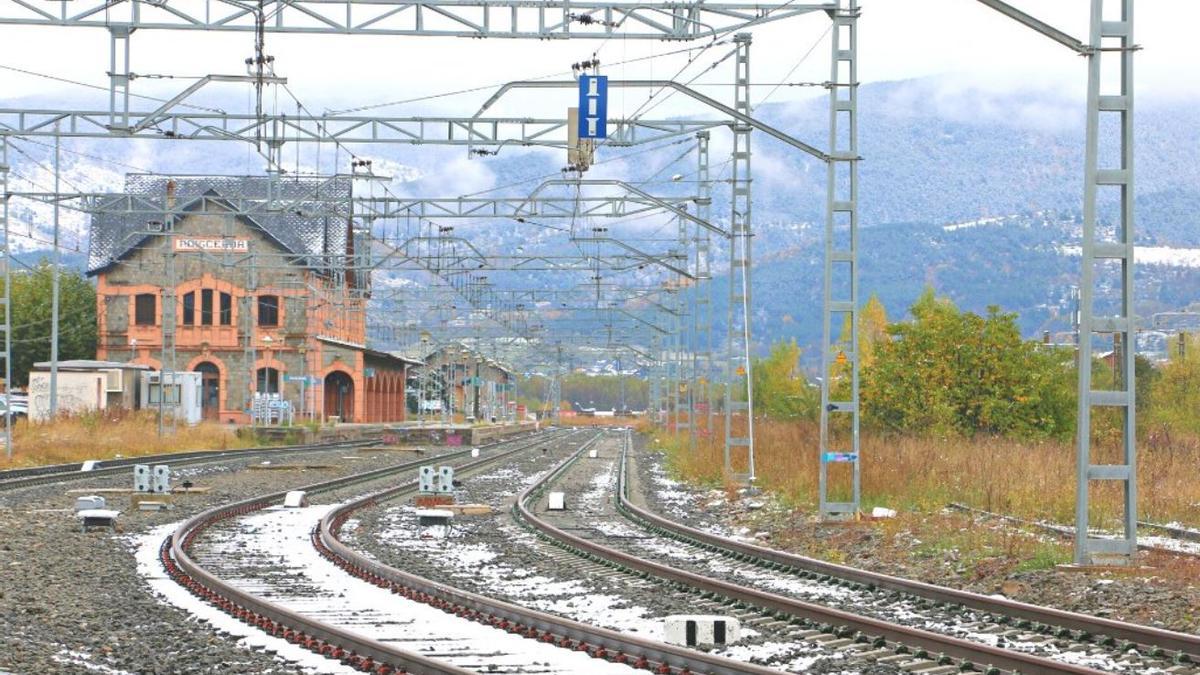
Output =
[{"x1": 634, "y1": 435, "x2": 1200, "y2": 634}]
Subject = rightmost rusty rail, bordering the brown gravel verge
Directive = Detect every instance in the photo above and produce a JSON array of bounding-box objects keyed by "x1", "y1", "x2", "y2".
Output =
[{"x1": 619, "y1": 454, "x2": 1200, "y2": 662}]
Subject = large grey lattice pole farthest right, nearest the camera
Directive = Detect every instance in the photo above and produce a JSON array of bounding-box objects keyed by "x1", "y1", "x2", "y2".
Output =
[{"x1": 1075, "y1": 0, "x2": 1138, "y2": 565}]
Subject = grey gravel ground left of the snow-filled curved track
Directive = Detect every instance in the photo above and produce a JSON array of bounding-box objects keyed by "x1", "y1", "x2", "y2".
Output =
[{"x1": 0, "y1": 432, "x2": 458, "y2": 674}]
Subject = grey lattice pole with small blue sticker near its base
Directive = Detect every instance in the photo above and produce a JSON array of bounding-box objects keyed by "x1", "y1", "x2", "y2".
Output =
[{"x1": 818, "y1": 0, "x2": 860, "y2": 518}]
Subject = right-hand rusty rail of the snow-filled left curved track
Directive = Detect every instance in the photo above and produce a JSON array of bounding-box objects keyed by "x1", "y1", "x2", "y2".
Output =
[{"x1": 317, "y1": 425, "x2": 780, "y2": 675}]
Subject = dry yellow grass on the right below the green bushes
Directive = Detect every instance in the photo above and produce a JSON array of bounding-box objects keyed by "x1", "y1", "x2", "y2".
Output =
[{"x1": 658, "y1": 420, "x2": 1200, "y2": 527}]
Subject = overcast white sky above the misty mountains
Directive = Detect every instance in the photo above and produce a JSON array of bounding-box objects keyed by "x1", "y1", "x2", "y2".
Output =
[{"x1": 0, "y1": 0, "x2": 1200, "y2": 117}]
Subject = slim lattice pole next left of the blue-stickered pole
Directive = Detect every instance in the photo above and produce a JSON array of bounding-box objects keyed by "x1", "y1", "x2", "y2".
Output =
[{"x1": 725, "y1": 32, "x2": 755, "y2": 485}]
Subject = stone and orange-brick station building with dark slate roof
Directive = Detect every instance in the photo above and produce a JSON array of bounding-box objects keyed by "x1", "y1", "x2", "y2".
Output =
[{"x1": 88, "y1": 174, "x2": 415, "y2": 423}]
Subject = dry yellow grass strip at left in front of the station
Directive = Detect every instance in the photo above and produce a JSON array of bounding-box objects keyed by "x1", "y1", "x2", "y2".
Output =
[{"x1": 0, "y1": 403, "x2": 256, "y2": 468}]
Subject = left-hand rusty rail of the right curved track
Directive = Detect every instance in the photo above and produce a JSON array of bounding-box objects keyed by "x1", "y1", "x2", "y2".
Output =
[{"x1": 515, "y1": 436, "x2": 1100, "y2": 675}]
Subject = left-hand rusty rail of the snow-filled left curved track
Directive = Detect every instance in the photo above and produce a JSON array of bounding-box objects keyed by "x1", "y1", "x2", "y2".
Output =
[{"x1": 160, "y1": 425, "x2": 541, "y2": 675}]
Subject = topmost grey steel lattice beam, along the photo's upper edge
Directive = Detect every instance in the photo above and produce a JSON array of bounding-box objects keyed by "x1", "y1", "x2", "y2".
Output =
[{"x1": 0, "y1": 0, "x2": 833, "y2": 41}]
